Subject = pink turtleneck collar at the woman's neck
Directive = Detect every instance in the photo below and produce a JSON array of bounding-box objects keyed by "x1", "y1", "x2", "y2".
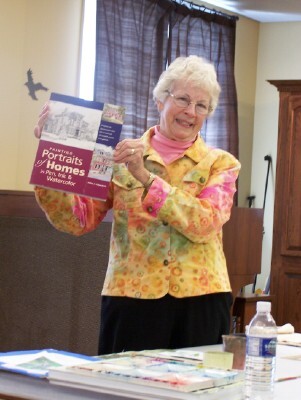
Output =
[{"x1": 151, "y1": 125, "x2": 195, "y2": 164}]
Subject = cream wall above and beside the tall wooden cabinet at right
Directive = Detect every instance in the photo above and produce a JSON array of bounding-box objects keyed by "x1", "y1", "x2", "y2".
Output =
[{"x1": 251, "y1": 22, "x2": 301, "y2": 288}]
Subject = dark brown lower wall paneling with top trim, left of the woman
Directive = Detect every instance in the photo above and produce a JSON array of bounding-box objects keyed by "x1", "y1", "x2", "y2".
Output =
[{"x1": 0, "y1": 191, "x2": 111, "y2": 355}]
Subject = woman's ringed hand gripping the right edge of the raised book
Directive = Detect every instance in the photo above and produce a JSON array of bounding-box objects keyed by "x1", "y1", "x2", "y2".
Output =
[{"x1": 114, "y1": 139, "x2": 149, "y2": 185}]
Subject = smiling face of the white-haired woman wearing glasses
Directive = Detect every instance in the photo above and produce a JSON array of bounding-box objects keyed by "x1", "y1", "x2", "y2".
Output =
[{"x1": 157, "y1": 82, "x2": 210, "y2": 142}]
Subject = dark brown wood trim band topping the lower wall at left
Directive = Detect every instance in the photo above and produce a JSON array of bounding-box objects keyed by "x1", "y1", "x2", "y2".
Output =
[{"x1": 0, "y1": 190, "x2": 45, "y2": 218}]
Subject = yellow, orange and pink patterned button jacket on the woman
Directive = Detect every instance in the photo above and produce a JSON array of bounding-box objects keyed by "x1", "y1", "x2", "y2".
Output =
[{"x1": 35, "y1": 128, "x2": 240, "y2": 299}]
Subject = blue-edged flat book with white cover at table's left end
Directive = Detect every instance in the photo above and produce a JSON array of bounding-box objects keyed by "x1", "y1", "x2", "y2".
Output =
[{"x1": 0, "y1": 349, "x2": 97, "y2": 378}]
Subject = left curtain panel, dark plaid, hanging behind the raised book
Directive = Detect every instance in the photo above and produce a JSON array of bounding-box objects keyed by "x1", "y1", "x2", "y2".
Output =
[{"x1": 94, "y1": 0, "x2": 169, "y2": 138}]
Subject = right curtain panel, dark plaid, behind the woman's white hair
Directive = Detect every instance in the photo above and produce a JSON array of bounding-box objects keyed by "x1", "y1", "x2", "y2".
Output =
[{"x1": 169, "y1": 5, "x2": 238, "y2": 157}]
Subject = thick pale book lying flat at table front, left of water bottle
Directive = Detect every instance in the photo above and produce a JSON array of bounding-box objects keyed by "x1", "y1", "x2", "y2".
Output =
[{"x1": 48, "y1": 351, "x2": 244, "y2": 393}]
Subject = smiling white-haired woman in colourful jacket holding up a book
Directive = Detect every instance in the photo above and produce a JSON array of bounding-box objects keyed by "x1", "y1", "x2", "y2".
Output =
[{"x1": 35, "y1": 56, "x2": 240, "y2": 354}]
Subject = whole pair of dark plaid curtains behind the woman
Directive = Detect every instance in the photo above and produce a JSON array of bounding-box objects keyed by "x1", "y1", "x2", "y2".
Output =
[{"x1": 94, "y1": 0, "x2": 238, "y2": 157}]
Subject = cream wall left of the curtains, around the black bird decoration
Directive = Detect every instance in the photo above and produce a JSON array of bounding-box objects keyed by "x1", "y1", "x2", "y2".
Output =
[{"x1": 0, "y1": 0, "x2": 82, "y2": 190}]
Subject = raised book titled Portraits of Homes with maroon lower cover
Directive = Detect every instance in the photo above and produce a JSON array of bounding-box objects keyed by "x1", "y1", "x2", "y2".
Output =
[{"x1": 30, "y1": 93, "x2": 125, "y2": 201}]
